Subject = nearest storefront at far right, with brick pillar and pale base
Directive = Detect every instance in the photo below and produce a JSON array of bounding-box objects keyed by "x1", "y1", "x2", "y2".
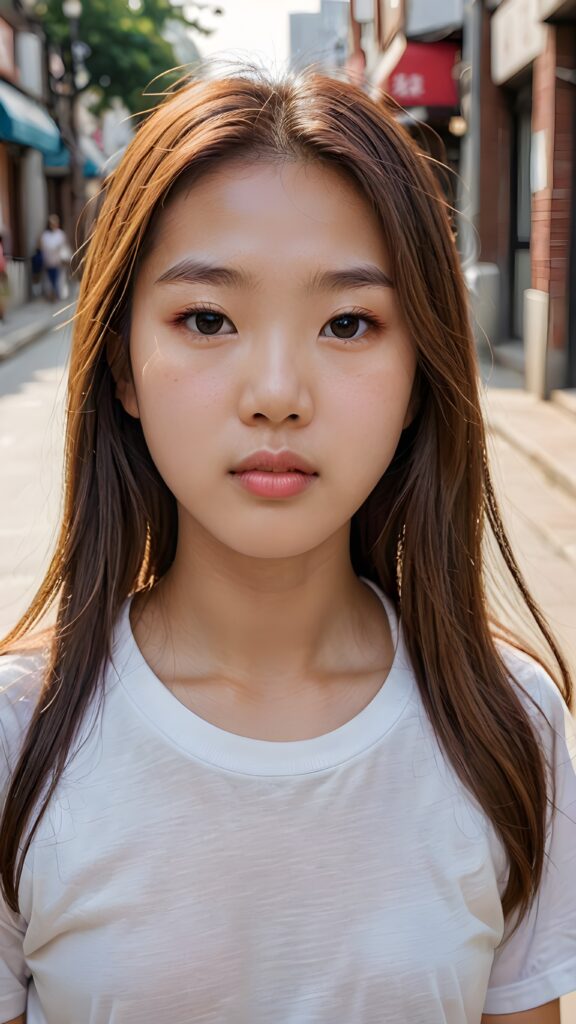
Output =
[{"x1": 482, "y1": 0, "x2": 576, "y2": 395}]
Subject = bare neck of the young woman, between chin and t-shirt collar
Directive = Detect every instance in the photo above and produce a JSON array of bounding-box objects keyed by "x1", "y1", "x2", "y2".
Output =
[{"x1": 135, "y1": 516, "x2": 389, "y2": 692}]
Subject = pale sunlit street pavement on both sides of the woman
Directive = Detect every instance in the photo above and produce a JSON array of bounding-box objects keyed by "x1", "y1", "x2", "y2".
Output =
[{"x1": 0, "y1": 319, "x2": 576, "y2": 1024}]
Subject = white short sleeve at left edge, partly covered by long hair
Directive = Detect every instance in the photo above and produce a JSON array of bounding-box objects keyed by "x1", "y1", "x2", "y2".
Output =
[{"x1": 0, "y1": 655, "x2": 42, "y2": 1021}]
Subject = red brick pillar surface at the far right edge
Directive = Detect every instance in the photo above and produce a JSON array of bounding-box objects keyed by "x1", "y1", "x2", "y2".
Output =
[{"x1": 531, "y1": 25, "x2": 576, "y2": 348}]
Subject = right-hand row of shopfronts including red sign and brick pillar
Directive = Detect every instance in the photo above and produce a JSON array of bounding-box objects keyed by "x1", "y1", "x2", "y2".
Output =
[{"x1": 347, "y1": 0, "x2": 576, "y2": 396}]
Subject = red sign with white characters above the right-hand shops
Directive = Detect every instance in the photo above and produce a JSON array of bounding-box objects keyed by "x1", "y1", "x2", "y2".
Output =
[{"x1": 383, "y1": 43, "x2": 459, "y2": 106}]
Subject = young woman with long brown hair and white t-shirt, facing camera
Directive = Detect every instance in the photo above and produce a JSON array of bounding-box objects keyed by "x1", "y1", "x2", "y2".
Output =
[{"x1": 0, "y1": 66, "x2": 576, "y2": 1024}]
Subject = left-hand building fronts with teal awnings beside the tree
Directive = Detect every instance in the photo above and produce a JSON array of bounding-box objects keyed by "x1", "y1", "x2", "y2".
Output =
[{"x1": 0, "y1": 0, "x2": 106, "y2": 305}]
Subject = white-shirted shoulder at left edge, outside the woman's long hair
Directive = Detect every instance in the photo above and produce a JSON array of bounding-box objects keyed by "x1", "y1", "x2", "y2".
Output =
[{"x1": 0, "y1": 652, "x2": 46, "y2": 765}]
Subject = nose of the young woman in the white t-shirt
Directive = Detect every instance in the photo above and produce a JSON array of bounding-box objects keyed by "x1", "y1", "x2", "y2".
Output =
[{"x1": 235, "y1": 332, "x2": 313, "y2": 423}]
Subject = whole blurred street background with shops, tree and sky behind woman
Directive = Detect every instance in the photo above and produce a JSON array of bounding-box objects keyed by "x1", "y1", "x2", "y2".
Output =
[{"x1": 0, "y1": 0, "x2": 576, "y2": 1011}]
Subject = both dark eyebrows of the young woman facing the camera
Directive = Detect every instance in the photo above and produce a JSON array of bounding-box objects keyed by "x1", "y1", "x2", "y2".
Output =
[{"x1": 155, "y1": 258, "x2": 394, "y2": 295}]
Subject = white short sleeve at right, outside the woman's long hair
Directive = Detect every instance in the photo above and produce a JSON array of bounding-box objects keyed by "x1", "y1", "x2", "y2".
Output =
[{"x1": 484, "y1": 660, "x2": 576, "y2": 1014}]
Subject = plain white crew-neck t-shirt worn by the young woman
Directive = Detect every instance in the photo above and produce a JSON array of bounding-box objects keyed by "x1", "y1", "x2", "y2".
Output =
[{"x1": 0, "y1": 578, "x2": 576, "y2": 1024}]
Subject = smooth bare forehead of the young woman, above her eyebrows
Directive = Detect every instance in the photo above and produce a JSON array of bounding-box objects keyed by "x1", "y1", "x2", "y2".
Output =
[{"x1": 141, "y1": 155, "x2": 387, "y2": 278}]
